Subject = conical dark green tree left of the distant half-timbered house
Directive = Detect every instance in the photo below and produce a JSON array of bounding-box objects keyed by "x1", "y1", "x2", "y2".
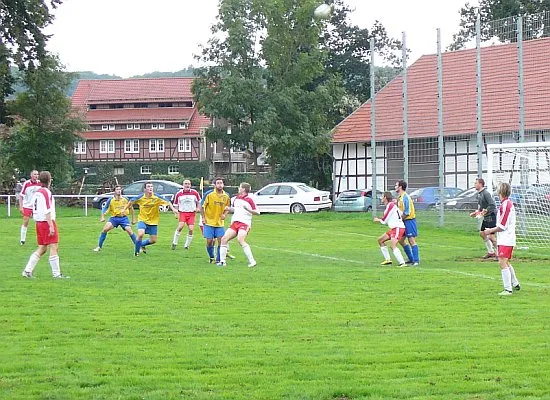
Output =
[{"x1": 2, "y1": 55, "x2": 86, "y2": 181}]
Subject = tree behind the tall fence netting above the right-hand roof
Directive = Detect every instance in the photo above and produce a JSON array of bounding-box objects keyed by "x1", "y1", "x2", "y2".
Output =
[{"x1": 449, "y1": 0, "x2": 550, "y2": 50}]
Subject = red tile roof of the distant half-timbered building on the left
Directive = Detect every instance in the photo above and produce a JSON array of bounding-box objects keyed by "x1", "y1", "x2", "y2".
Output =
[{"x1": 72, "y1": 78, "x2": 210, "y2": 139}]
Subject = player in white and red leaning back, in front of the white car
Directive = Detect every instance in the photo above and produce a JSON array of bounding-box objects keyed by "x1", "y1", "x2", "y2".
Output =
[{"x1": 217, "y1": 182, "x2": 260, "y2": 268}]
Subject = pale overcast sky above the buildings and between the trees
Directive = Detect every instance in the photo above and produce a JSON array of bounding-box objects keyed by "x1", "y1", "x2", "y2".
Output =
[{"x1": 46, "y1": 0, "x2": 477, "y2": 78}]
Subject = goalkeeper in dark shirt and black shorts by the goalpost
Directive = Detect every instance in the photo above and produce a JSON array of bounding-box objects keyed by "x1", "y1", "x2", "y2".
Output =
[{"x1": 470, "y1": 178, "x2": 498, "y2": 261}]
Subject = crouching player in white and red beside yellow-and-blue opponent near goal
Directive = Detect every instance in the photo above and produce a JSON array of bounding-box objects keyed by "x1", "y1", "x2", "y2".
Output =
[{"x1": 374, "y1": 192, "x2": 407, "y2": 267}]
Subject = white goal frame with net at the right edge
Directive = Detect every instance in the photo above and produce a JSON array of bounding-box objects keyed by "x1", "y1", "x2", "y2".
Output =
[{"x1": 487, "y1": 142, "x2": 550, "y2": 248}]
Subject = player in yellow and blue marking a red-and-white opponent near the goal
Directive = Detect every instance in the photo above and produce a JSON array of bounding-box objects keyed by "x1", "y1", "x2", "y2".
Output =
[{"x1": 395, "y1": 180, "x2": 420, "y2": 266}]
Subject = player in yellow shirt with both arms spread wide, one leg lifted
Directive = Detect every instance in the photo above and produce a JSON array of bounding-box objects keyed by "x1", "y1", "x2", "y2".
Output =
[{"x1": 126, "y1": 182, "x2": 179, "y2": 256}]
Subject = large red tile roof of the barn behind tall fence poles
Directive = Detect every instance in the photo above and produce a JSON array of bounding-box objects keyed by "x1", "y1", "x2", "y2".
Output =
[{"x1": 333, "y1": 38, "x2": 550, "y2": 143}]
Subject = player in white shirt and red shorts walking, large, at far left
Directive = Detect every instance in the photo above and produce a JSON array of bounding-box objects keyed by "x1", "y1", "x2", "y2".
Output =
[{"x1": 22, "y1": 171, "x2": 68, "y2": 278}]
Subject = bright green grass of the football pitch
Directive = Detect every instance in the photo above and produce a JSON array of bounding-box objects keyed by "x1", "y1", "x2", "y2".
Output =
[{"x1": 0, "y1": 209, "x2": 550, "y2": 400}]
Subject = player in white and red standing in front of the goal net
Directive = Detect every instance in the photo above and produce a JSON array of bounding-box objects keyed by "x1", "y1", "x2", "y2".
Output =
[{"x1": 485, "y1": 182, "x2": 520, "y2": 296}]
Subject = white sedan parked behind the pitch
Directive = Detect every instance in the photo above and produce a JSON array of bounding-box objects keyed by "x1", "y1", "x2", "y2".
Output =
[{"x1": 252, "y1": 182, "x2": 332, "y2": 214}]
